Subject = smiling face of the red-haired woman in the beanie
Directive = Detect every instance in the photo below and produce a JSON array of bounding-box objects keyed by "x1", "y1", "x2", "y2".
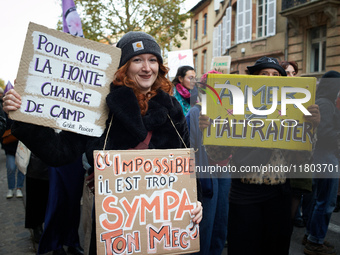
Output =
[{"x1": 127, "y1": 54, "x2": 159, "y2": 94}]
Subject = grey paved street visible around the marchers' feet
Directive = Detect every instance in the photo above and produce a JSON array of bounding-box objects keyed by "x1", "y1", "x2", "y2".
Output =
[{"x1": 0, "y1": 146, "x2": 340, "y2": 255}]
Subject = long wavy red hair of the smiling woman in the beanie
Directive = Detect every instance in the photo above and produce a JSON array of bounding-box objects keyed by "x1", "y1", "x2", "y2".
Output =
[{"x1": 111, "y1": 59, "x2": 172, "y2": 115}]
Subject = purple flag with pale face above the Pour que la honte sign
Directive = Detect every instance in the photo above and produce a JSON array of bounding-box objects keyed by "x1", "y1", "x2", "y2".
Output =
[{"x1": 62, "y1": 0, "x2": 84, "y2": 37}]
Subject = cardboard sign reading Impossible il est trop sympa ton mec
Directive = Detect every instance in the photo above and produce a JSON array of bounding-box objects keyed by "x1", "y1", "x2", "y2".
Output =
[{"x1": 94, "y1": 149, "x2": 199, "y2": 255}]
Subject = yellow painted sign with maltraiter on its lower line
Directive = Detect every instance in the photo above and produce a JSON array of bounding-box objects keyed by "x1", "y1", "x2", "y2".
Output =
[{"x1": 202, "y1": 74, "x2": 316, "y2": 151}]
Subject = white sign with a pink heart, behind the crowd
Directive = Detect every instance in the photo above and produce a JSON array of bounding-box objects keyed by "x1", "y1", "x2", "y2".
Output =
[{"x1": 168, "y1": 50, "x2": 194, "y2": 78}]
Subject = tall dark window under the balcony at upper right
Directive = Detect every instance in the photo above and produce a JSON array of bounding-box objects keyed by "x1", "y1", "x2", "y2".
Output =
[{"x1": 309, "y1": 26, "x2": 327, "y2": 73}]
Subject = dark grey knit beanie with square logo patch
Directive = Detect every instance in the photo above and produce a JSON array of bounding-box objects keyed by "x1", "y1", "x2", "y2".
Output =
[{"x1": 116, "y1": 31, "x2": 163, "y2": 68}]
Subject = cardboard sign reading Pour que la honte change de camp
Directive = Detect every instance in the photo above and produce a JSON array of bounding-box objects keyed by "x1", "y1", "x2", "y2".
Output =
[{"x1": 9, "y1": 23, "x2": 121, "y2": 136}]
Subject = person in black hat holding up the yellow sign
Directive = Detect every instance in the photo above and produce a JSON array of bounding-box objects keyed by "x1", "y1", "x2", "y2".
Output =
[{"x1": 200, "y1": 57, "x2": 320, "y2": 255}]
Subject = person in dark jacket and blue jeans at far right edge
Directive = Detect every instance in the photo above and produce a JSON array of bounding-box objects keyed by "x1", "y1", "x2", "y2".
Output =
[{"x1": 303, "y1": 71, "x2": 340, "y2": 255}]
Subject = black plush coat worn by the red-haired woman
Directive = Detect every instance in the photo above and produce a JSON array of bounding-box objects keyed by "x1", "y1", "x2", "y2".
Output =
[{"x1": 12, "y1": 86, "x2": 190, "y2": 169}]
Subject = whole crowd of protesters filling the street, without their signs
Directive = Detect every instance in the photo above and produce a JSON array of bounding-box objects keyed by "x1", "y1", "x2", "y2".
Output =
[{"x1": 0, "y1": 28, "x2": 340, "y2": 255}]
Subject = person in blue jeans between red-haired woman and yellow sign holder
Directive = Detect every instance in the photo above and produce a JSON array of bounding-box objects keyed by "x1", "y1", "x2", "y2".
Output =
[{"x1": 186, "y1": 70, "x2": 231, "y2": 255}]
